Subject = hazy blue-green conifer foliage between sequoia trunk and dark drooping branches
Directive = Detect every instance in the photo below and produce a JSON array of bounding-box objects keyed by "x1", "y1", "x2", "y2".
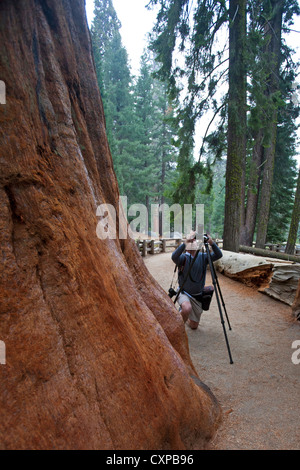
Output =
[{"x1": 92, "y1": 0, "x2": 177, "y2": 209}]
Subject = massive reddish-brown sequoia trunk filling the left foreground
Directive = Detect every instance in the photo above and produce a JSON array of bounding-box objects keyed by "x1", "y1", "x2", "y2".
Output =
[{"x1": 0, "y1": 0, "x2": 220, "y2": 449}]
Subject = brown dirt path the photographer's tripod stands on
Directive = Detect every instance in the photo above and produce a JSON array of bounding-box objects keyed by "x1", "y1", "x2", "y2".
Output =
[{"x1": 144, "y1": 253, "x2": 300, "y2": 450}]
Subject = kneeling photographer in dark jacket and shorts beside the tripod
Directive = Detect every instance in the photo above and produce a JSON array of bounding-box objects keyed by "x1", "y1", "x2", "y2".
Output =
[{"x1": 172, "y1": 232, "x2": 223, "y2": 330}]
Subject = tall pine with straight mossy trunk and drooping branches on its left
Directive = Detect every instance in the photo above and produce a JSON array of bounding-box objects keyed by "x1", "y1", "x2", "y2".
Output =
[{"x1": 150, "y1": 0, "x2": 246, "y2": 251}]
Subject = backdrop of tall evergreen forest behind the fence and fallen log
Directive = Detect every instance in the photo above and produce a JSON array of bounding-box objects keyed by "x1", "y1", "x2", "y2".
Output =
[{"x1": 91, "y1": 0, "x2": 300, "y2": 253}]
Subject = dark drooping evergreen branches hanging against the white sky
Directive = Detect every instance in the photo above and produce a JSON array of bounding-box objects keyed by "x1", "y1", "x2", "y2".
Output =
[{"x1": 149, "y1": 0, "x2": 228, "y2": 203}]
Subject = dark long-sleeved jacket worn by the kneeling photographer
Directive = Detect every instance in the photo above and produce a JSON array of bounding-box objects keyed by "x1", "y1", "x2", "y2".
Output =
[{"x1": 172, "y1": 243, "x2": 223, "y2": 294}]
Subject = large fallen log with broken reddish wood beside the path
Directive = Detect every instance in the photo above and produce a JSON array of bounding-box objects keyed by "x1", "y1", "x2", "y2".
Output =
[{"x1": 215, "y1": 250, "x2": 300, "y2": 306}]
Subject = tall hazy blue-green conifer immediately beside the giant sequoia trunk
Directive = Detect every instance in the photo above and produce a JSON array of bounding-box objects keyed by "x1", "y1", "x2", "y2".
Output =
[{"x1": 91, "y1": 0, "x2": 136, "y2": 200}]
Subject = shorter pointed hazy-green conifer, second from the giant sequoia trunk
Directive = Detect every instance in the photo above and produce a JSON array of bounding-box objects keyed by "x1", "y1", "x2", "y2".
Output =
[{"x1": 134, "y1": 53, "x2": 176, "y2": 212}]
